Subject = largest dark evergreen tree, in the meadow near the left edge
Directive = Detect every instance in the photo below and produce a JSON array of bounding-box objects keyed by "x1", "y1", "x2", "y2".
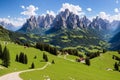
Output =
[{"x1": 2, "y1": 46, "x2": 10, "y2": 67}]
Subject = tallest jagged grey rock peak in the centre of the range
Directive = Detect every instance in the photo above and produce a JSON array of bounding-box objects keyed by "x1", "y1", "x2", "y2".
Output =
[{"x1": 52, "y1": 9, "x2": 79, "y2": 29}]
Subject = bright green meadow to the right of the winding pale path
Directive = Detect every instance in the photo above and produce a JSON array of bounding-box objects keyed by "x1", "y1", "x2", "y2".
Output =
[{"x1": 20, "y1": 52, "x2": 120, "y2": 80}]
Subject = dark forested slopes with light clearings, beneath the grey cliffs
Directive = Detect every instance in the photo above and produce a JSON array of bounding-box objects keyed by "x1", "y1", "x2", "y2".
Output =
[{"x1": 0, "y1": 27, "x2": 107, "y2": 48}]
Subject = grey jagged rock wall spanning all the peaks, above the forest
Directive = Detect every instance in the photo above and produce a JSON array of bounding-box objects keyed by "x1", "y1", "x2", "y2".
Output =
[{"x1": 19, "y1": 9, "x2": 113, "y2": 32}]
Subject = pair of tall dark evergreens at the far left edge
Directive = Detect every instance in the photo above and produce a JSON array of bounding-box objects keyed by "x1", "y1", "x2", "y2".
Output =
[{"x1": 0, "y1": 44, "x2": 10, "y2": 68}]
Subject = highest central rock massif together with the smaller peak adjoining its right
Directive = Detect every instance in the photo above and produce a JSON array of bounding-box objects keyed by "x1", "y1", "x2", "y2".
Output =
[{"x1": 52, "y1": 9, "x2": 90, "y2": 29}]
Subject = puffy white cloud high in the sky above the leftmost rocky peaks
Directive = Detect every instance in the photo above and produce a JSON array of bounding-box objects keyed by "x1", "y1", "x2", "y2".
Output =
[{"x1": 21, "y1": 5, "x2": 38, "y2": 16}]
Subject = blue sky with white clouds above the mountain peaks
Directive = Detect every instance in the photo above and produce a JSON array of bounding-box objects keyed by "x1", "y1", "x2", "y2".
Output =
[{"x1": 0, "y1": 0, "x2": 120, "y2": 27}]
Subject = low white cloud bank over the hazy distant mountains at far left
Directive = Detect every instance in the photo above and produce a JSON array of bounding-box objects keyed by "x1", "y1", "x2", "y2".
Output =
[{"x1": 0, "y1": 18, "x2": 26, "y2": 27}]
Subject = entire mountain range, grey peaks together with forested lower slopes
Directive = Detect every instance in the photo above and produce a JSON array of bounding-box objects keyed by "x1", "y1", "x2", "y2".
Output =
[{"x1": 0, "y1": 9, "x2": 120, "y2": 48}]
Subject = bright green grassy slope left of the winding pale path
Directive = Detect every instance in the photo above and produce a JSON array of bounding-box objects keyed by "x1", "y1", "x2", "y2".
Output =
[{"x1": 0, "y1": 42, "x2": 45, "y2": 76}]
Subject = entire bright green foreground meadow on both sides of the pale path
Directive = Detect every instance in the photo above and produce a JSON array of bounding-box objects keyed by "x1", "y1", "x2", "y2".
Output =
[{"x1": 0, "y1": 42, "x2": 120, "y2": 80}]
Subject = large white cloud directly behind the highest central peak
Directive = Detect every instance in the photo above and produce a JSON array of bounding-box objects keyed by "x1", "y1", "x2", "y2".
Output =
[{"x1": 60, "y1": 3, "x2": 84, "y2": 15}]
